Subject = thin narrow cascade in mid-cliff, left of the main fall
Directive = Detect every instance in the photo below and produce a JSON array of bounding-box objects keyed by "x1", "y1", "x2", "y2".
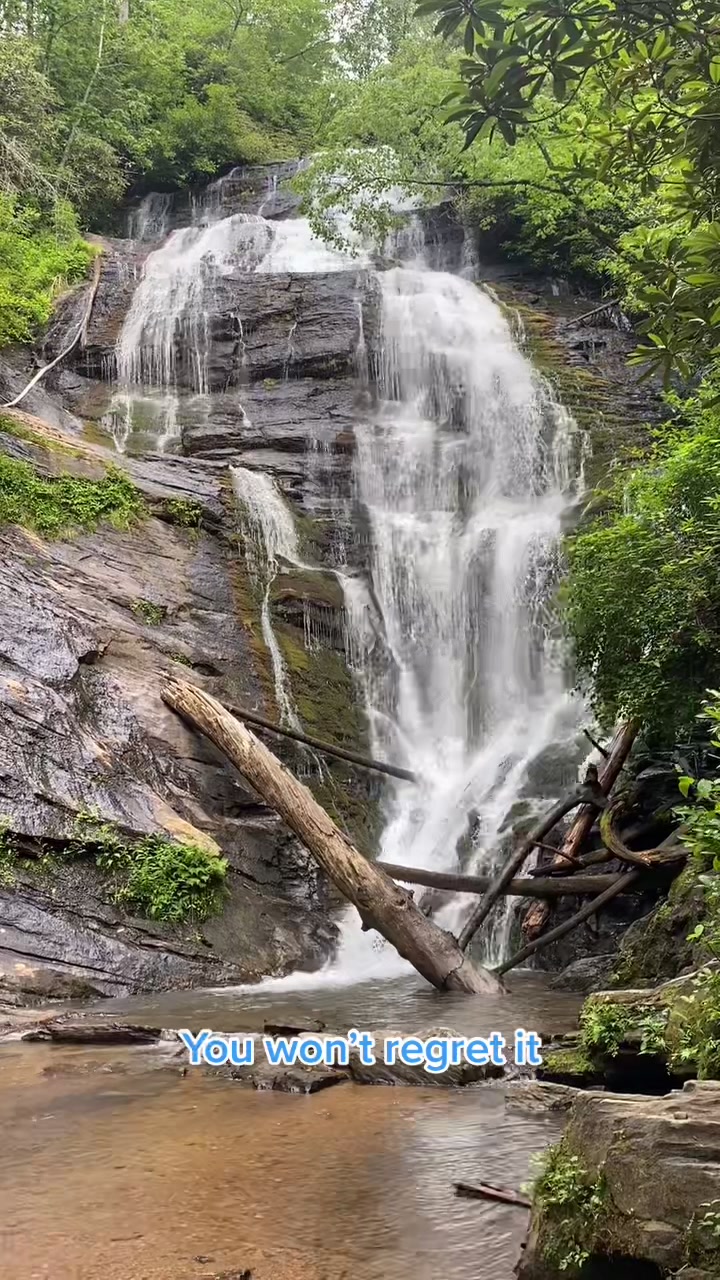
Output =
[{"x1": 231, "y1": 467, "x2": 301, "y2": 730}]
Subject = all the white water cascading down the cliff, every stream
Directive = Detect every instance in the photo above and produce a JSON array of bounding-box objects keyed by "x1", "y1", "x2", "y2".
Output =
[{"x1": 110, "y1": 165, "x2": 584, "y2": 984}]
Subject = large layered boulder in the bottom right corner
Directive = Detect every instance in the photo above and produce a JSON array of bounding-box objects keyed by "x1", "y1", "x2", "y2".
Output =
[{"x1": 518, "y1": 1083, "x2": 720, "y2": 1280}]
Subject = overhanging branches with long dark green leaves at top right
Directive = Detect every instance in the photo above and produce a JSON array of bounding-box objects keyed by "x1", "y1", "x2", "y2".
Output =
[{"x1": 416, "y1": 0, "x2": 720, "y2": 379}]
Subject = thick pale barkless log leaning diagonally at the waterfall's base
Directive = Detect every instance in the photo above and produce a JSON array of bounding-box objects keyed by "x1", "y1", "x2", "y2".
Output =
[{"x1": 163, "y1": 680, "x2": 502, "y2": 995}]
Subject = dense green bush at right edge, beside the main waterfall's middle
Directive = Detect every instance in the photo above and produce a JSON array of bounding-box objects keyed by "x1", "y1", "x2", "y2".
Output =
[{"x1": 564, "y1": 385, "x2": 720, "y2": 742}]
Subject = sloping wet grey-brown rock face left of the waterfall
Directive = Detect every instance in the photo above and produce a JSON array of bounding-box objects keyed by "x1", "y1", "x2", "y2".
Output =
[{"x1": 0, "y1": 419, "x2": 334, "y2": 995}]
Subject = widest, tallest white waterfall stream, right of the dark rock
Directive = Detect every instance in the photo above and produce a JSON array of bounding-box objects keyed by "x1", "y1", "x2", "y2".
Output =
[{"x1": 345, "y1": 268, "x2": 582, "y2": 972}]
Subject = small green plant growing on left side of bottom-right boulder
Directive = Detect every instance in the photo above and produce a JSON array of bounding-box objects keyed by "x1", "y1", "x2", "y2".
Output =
[{"x1": 533, "y1": 1140, "x2": 607, "y2": 1271}]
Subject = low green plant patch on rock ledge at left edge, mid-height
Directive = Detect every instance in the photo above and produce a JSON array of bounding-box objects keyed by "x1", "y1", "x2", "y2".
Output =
[{"x1": 0, "y1": 454, "x2": 145, "y2": 538}]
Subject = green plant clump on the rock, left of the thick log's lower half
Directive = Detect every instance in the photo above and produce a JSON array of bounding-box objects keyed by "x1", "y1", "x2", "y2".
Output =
[{"x1": 69, "y1": 812, "x2": 228, "y2": 924}]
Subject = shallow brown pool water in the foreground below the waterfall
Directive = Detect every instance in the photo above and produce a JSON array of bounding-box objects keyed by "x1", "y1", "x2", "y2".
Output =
[{"x1": 0, "y1": 984, "x2": 577, "y2": 1280}]
